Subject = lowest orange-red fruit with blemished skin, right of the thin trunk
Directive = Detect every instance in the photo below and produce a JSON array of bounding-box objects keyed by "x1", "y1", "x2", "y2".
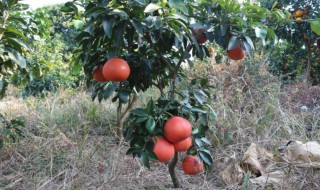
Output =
[{"x1": 182, "y1": 155, "x2": 203, "y2": 175}]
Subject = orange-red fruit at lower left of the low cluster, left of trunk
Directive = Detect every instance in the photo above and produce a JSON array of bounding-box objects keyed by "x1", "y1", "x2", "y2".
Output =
[{"x1": 153, "y1": 137, "x2": 174, "y2": 162}]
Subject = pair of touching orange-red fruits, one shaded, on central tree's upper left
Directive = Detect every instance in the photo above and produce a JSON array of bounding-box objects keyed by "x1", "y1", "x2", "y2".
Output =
[{"x1": 93, "y1": 58, "x2": 130, "y2": 82}]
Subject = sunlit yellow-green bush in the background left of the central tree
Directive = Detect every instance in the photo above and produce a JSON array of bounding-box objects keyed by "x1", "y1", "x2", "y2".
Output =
[{"x1": 11, "y1": 6, "x2": 81, "y2": 97}]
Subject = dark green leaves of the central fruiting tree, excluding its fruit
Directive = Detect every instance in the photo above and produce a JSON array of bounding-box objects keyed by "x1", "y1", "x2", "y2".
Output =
[{"x1": 63, "y1": 0, "x2": 286, "y2": 174}]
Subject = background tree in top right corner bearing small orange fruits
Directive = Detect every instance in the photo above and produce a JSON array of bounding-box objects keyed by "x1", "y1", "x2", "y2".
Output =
[{"x1": 263, "y1": 0, "x2": 320, "y2": 84}]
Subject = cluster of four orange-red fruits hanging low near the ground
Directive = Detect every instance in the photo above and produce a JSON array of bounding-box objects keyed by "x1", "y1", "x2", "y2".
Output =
[{"x1": 153, "y1": 116, "x2": 203, "y2": 175}]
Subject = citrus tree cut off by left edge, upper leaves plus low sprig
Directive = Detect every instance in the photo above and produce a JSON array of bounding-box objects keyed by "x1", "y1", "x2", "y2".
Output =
[{"x1": 0, "y1": 0, "x2": 33, "y2": 149}]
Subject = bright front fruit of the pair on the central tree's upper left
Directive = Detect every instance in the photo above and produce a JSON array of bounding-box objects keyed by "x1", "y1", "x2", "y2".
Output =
[{"x1": 102, "y1": 58, "x2": 130, "y2": 82}]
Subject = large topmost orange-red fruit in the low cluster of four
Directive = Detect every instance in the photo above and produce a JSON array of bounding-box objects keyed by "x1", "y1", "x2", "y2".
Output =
[{"x1": 163, "y1": 116, "x2": 192, "y2": 143}]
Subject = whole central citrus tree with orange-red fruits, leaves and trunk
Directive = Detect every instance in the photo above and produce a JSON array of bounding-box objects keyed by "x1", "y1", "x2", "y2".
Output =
[{"x1": 63, "y1": 0, "x2": 285, "y2": 187}]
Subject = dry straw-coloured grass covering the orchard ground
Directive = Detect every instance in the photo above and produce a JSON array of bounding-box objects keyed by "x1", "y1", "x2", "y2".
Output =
[{"x1": 0, "y1": 59, "x2": 320, "y2": 190}]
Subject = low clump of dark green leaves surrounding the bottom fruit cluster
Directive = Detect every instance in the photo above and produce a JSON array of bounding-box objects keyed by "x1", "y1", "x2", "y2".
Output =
[{"x1": 125, "y1": 79, "x2": 216, "y2": 167}]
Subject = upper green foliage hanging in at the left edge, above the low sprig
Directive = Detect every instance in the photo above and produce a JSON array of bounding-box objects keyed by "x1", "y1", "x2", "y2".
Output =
[{"x1": 0, "y1": 0, "x2": 30, "y2": 98}]
